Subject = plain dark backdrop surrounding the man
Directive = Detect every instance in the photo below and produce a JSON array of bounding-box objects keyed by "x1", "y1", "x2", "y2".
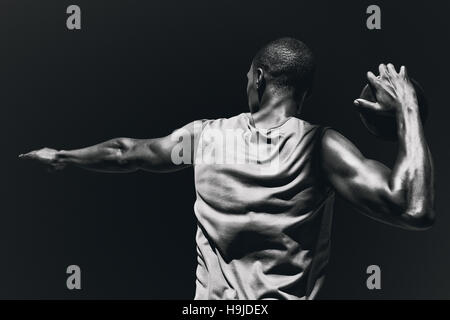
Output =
[{"x1": 0, "y1": 0, "x2": 450, "y2": 299}]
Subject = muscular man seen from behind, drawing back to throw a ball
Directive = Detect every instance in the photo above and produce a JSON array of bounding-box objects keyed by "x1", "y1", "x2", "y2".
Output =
[{"x1": 20, "y1": 38, "x2": 434, "y2": 299}]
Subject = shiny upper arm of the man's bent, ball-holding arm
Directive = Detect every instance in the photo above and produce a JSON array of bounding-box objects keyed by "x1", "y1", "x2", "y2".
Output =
[{"x1": 321, "y1": 130, "x2": 402, "y2": 225}]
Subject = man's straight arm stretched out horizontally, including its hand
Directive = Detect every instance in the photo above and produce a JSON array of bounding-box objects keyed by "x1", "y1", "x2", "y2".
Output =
[{"x1": 19, "y1": 121, "x2": 201, "y2": 172}]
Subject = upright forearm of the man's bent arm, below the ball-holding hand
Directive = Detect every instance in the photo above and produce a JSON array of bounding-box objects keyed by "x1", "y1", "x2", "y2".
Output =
[{"x1": 390, "y1": 100, "x2": 434, "y2": 225}]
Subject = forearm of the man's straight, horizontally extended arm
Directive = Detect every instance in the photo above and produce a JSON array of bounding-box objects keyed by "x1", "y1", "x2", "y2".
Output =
[{"x1": 56, "y1": 138, "x2": 137, "y2": 172}]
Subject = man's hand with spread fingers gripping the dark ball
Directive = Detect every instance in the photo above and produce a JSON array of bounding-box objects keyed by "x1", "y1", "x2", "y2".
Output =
[{"x1": 354, "y1": 63, "x2": 419, "y2": 115}]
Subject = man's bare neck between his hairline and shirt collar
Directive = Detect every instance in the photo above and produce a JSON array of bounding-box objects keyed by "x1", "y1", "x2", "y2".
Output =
[{"x1": 251, "y1": 95, "x2": 299, "y2": 129}]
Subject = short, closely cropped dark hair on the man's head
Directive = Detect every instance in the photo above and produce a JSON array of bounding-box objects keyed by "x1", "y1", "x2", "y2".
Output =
[{"x1": 252, "y1": 37, "x2": 316, "y2": 93}]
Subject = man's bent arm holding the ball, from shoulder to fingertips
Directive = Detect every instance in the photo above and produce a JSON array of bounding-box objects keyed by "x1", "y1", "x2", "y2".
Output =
[{"x1": 322, "y1": 64, "x2": 435, "y2": 230}]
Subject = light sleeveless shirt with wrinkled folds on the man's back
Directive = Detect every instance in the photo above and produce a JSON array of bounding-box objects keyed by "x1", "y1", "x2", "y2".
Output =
[{"x1": 194, "y1": 113, "x2": 334, "y2": 299}]
